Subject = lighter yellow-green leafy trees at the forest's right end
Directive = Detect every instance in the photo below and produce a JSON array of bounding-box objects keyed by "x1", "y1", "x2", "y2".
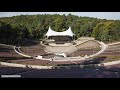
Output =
[{"x1": 92, "y1": 21, "x2": 120, "y2": 42}]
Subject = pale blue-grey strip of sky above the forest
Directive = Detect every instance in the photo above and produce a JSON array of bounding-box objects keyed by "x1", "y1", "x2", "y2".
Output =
[{"x1": 0, "y1": 12, "x2": 120, "y2": 20}]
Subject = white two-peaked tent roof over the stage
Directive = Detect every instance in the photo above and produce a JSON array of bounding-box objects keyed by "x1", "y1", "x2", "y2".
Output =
[{"x1": 46, "y1": 27, "x2": 74, "y2": 37}]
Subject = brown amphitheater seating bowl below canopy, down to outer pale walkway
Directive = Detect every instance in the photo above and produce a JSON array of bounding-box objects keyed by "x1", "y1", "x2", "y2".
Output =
[{"x1": 0, "y1": 26, "x2": 120, "y2": 69}]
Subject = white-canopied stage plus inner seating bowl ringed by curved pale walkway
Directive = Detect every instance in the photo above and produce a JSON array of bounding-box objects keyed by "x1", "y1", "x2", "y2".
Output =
[{"x1": 14, "y1": 27, "x2": 107, "y2": 63}]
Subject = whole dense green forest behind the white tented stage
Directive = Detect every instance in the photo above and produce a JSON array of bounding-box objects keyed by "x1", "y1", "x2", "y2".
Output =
[{"x1": 0, "y1": 14, "x2": 120, "y2": 44}]
